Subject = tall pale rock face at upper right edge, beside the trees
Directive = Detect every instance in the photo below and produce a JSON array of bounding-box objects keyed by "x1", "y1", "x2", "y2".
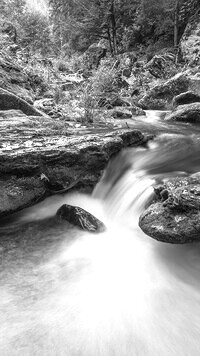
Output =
[{"x1": 180, "y1": 10, "x2": 200, "y2": 66}]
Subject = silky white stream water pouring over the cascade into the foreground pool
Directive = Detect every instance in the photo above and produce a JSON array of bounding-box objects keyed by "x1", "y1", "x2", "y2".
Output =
[{"x1": 0, "y1": 114, "x2": 200, "y2": 356}]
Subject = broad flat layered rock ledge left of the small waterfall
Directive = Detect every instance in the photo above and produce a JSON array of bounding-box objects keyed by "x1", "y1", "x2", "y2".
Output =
[{"x1": 0, "y1": 110, "x2": 146, "y2": 217}]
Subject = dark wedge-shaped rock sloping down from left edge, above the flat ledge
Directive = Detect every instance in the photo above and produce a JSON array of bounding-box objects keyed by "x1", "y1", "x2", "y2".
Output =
[{"x1": 0, "y1": 88, "x2": 42, "y2": 116}]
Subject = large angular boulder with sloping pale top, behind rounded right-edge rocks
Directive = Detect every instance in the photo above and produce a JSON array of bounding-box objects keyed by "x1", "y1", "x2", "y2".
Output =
[{"x1": 138, "y1": 73, "x2": 190, "y2": 110}]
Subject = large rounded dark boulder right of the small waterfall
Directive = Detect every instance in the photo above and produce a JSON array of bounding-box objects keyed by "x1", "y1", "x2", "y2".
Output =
[{"x1": 139, "y1": 174, "x2": 200, "y2": 244}]
